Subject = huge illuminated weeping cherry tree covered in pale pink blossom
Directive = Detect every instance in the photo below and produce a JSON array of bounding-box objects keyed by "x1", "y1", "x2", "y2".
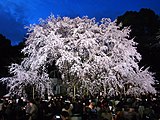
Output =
[{"x1": 1, "y1": 16, "x2": 155, "y2": 95}]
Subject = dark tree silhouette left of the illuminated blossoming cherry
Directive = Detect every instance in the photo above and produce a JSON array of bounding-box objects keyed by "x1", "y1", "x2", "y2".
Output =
[{"x1": 0, "y1": 34, "x2": 23, "y2": 96}]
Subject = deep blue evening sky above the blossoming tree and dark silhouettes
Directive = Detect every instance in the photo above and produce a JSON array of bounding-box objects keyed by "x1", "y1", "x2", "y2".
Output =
[{"x1": 0, "y1": 0, "x2": 160, "y2": 45}]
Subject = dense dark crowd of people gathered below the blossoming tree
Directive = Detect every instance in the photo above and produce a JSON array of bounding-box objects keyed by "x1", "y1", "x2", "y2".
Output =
[{"x1": 0, "y1": 95, "x2": 160, "y2": 120}]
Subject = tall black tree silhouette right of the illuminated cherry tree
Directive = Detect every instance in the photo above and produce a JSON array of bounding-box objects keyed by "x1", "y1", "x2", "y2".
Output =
[{"x1": 117, "y1": 8, "x2": 160, "y2": 80}]
